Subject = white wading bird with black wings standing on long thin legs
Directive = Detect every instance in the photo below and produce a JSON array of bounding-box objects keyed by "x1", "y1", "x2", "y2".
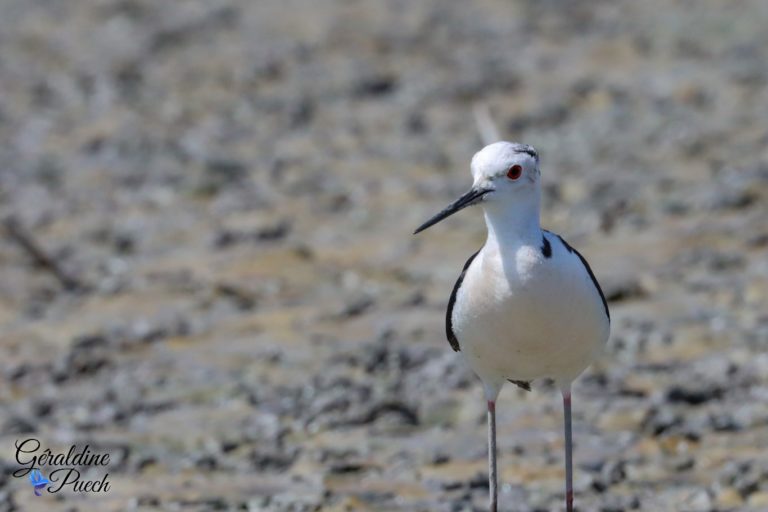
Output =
[{"x1": 414, "y1": 142, "x2": 610, "y2": 512}]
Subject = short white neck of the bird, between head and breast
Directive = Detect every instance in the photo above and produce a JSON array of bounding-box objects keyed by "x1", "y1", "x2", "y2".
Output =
[{"x1": 483, "y1": 193, "x2": 542, "y2": 250}]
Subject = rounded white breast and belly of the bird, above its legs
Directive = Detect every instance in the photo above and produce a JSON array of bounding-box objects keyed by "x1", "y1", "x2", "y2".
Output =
[{"x1": 451, "y1": 241, "x2": 609, "y2": 385}]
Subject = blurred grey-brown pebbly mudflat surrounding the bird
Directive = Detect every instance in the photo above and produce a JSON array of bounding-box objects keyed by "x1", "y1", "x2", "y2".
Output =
[{"x1": 0, "y1": 0, "x2": 768, "y2": 512}]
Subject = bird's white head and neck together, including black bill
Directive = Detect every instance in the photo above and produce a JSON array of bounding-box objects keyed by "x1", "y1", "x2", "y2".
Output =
[{"x1": 415, "y1": 142, "x2": 541, "y2": 236}]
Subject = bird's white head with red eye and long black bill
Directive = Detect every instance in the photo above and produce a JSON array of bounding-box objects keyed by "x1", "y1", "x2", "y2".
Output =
[{"x1": 414, "y1": 142, "x2": 541, "y2": 234}]
